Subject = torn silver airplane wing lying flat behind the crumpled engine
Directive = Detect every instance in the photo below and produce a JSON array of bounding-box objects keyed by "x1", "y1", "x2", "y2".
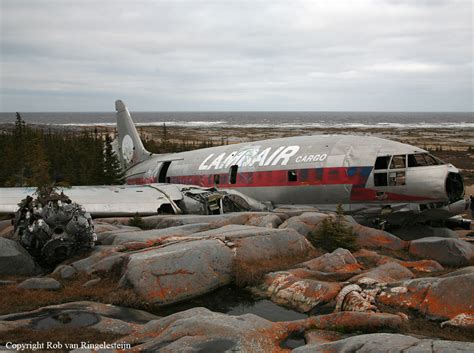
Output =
[{"x1": 0, "y1": 184, "x2": 264, "y2": 217}]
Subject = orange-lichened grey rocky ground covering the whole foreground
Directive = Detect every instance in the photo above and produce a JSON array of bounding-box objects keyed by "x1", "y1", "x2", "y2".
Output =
[{"x1": 0, "y1": 208, "x2": 474, "y2": 352}]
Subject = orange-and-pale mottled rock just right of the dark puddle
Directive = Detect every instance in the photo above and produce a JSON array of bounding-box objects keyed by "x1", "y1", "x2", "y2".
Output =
[{"x1": 258, "y1": 272, "x2": 342, "y2": 312}]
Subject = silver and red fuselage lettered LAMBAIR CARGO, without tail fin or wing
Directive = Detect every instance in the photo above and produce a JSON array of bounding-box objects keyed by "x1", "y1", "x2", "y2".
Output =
[{"x1": 127, "y1": 135, "x2": 463, "y2": 212}]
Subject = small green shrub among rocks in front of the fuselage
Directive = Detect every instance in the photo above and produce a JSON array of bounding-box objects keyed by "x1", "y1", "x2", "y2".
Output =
[{"x1": 308, "y1": 205, "x2": 359, "y2": 252}]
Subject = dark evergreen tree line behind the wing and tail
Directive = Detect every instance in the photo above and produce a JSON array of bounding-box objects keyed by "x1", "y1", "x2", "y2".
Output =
[{"x1": 0, "y1": 113, "x2": 222, "y2": 186}]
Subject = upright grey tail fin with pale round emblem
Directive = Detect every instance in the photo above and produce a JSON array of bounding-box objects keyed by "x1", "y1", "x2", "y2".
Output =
[{"x1": 115, "y1": 100, "x2": 151, "y2": 170}]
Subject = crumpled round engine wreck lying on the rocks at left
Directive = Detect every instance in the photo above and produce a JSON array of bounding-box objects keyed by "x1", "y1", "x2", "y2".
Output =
[{"x1": 14, "y1": 188, "x2": 97, "y2": 266}]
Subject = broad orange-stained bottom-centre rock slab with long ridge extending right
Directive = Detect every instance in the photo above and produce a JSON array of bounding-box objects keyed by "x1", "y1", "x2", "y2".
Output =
[{"x1": 119, "y1": 308, "x2": 401, "y2": 352}]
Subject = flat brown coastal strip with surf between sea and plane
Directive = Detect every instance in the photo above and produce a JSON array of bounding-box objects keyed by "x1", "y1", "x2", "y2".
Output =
[{"x1": 0, "y1": 123, "x2": 474, "y2": 184}]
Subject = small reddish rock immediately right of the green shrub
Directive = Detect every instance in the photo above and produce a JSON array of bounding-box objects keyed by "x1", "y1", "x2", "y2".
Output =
[{"x1": 352, "y1": 224, "x2": 407, "y2": 250}]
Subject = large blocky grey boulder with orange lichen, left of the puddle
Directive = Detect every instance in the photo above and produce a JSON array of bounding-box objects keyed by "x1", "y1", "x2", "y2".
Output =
[{"x1": 120, "y1": 239, "x2": 232, "y2": 305}]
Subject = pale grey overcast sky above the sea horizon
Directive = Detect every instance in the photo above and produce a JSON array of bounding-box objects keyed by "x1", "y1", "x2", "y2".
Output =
[{"x1": 0, "y1": 0, "x2": 474, "y2": 111}]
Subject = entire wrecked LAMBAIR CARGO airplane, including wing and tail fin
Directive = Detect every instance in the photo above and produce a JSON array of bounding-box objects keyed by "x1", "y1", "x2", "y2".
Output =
[{"x1": 0, "y1": 100, "x2": 469, "y2": 225}]
